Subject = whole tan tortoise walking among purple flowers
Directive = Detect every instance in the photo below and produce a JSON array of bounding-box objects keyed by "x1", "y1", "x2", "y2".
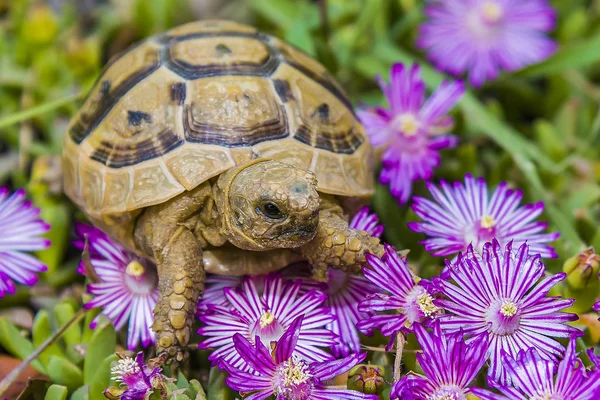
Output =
[{"x1": 63, "y1": 21, "x2": 383, "y2": 363}]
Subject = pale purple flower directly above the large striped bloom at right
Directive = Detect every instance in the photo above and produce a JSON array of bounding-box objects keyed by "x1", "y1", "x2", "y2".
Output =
[{"x1": 408, "y1": 175, "x2": 560, "y2": 258}]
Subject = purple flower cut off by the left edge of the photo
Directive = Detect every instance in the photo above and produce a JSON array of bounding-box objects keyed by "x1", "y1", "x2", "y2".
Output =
[{"x1": 0, "y1": 187, "x2": 50, "y2": 298}]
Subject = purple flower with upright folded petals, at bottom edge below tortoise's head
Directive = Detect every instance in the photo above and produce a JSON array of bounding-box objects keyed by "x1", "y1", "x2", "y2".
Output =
[{"x1": 221, "y1": 315, "x2": 378, "y2": 400}]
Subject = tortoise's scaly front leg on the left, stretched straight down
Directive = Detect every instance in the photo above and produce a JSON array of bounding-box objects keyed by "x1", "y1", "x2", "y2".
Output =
[{"x1": 135, "y1": 187, "x2": 210, "y2": 364}]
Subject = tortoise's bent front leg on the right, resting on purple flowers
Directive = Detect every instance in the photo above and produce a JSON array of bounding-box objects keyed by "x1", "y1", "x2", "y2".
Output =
[{"x1": 301, "y1": 197, "x2": 384, "y2": 281}]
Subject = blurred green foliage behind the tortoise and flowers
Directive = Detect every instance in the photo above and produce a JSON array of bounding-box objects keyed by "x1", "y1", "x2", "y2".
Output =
[{"x1": 0, "y1": 0, "x2": 600, "y2": 396}]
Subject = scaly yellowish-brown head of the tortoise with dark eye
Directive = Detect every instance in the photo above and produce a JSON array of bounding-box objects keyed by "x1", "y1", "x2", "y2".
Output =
[{"x1": 217, "y1": 160, "x2": 320, "y2": 251}]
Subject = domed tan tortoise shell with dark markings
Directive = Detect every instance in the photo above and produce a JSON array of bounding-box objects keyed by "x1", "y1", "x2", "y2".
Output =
[{"x1": 64, "y1": 21, "x2": 374, "y2": 216}]
